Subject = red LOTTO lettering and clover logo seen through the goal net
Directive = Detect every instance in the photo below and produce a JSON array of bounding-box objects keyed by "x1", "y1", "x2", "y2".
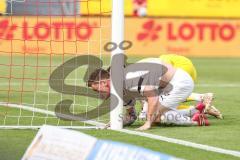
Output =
[{"x1": 0, "y1": 19, "x2": 96, "y2": 40}]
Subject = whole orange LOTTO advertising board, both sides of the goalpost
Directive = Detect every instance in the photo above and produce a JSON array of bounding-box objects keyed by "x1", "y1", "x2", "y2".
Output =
[{"x1": 0, "y1": 17, "x2": 240, "y2": 57}]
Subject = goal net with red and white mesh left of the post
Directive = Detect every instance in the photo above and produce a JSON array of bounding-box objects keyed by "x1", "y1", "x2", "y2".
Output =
[{"x1": 0, "y1": 0, "x2": 123, "y2": 129}]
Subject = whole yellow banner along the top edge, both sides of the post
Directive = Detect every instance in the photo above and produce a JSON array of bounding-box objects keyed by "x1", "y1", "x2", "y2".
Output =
[{"x1": 80, "y1": 0, "x2": 240, "y2": 18}]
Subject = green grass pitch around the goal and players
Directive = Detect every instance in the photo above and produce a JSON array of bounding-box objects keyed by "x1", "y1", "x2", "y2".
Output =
[{"x1": 0, "y1": 55, "x2": 240, "y2": 160}]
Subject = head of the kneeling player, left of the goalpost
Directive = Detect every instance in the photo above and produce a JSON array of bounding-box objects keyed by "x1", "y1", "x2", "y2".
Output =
[{"x1": 87, "y1": 68, "x2": 110, "y2": 98}]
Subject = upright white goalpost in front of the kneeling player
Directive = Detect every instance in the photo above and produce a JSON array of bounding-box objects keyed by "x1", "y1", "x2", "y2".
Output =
[{"x1": 110, "y1": 0, "x2": 124, "y2": 130}]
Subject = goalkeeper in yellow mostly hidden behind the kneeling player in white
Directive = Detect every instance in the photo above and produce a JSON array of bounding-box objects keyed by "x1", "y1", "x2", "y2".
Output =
[{"x1": 139, "y1": 54, "x2": 223, "y2": 119}]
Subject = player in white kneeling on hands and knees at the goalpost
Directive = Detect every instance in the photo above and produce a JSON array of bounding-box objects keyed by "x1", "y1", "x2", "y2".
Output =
[{"x1": 88, "y1": 58, "x2": 209, "y2": 130}]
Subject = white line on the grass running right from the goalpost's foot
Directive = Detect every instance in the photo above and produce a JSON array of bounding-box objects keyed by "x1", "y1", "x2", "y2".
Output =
[{"x1": 118, "y1": 129, "x2": 240, "y2": 157}]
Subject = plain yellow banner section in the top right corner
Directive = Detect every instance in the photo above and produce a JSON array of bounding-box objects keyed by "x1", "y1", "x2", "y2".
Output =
[{"x1": 147, "y1": 0, "x2": 240, "y2": 18}]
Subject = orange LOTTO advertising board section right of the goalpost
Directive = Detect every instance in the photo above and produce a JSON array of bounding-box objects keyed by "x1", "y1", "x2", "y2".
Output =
[{"x1": 126, "y1": 18, "x2": 240, "y2": 57}]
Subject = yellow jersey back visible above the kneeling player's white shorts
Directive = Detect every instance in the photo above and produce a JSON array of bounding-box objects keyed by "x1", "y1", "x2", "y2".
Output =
[{"x1": 159, "y1": 54, "x2": 197, "y2": 81}]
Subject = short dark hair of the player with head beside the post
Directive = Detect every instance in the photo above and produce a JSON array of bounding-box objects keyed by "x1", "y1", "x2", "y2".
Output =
[{"x1": 87, "y1": 68, "x2": 110, "y2": 87}]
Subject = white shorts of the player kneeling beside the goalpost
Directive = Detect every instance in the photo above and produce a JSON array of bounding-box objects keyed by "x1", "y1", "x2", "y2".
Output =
[{"x1": 159, "y1": 68, "x2": 194, "y2": 110}]
